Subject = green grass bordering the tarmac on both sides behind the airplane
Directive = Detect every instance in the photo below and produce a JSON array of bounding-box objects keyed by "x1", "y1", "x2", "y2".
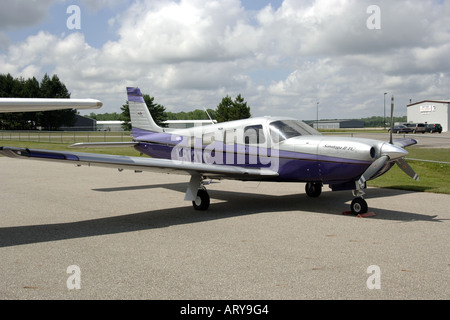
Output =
[{"x1": 0, "y1": 140, "x2": 450, "y2": 194}]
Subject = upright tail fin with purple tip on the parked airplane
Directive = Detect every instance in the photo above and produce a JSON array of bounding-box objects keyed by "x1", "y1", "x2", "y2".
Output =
[{"x1": 127, "y1": 87, "x2": 164, "y2": 133}]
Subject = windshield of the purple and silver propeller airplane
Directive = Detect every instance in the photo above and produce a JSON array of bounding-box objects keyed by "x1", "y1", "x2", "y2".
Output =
[{"x1": 270, "y1": 120, "x2": 320, "y2": 142}]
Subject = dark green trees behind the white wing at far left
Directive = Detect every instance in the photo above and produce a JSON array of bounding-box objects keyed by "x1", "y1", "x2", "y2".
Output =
[{"x1": 0, "y1": 73, "x2": 77, "y2": 130}]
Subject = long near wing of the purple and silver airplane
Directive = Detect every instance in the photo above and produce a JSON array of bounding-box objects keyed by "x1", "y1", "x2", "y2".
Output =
[{"x1": 0, "y1": 147, "x2": 278, "y2": 180}]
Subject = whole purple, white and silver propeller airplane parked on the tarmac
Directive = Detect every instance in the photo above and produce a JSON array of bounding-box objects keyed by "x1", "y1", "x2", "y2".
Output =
[{"x1": 0, "y1": 87, "x2": 419, "y2": 215}]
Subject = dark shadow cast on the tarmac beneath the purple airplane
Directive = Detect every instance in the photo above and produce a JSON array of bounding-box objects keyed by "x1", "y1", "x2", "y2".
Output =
[{"x1": 0, "y1": 183, "x2": 443, "y2": 247}]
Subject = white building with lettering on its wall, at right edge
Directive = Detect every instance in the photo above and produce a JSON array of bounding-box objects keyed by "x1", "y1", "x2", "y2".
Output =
[{"x1": 406, "y1": 100, "x2": 450, "y2": 131}]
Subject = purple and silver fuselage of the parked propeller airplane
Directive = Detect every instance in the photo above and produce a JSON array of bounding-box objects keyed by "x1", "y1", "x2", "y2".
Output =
[{"x1": 133, "y1": 117, "x2": 406, "y2": 185}]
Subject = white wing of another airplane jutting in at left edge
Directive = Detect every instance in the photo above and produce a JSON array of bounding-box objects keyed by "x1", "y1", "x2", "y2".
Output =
[{"x1": 0, "y1": 98, "x2": 103, "y2": 113}]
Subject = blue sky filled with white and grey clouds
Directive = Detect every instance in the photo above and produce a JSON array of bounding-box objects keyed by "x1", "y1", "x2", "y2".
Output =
[{"x1": 0, "y1": 0, "x2": 450, "y2": 120}]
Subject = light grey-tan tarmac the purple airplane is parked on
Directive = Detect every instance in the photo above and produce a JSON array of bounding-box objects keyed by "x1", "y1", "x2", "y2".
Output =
[{"x1": 0, "y1": 136, "x2": 450, "y2": 300}]
